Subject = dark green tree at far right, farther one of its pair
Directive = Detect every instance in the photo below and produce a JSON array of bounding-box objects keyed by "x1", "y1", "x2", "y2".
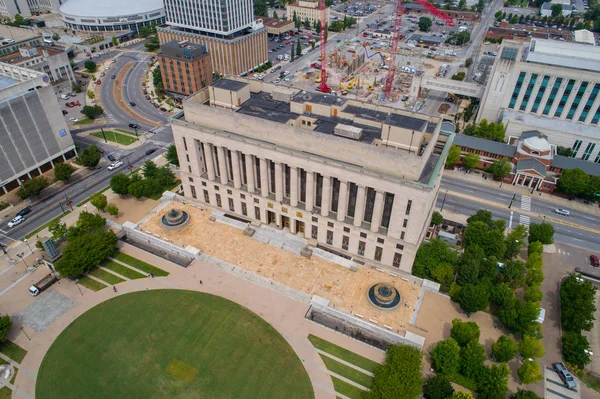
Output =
[{"x1": 560, "y1": 274, "x2": 596, "y2": 333}]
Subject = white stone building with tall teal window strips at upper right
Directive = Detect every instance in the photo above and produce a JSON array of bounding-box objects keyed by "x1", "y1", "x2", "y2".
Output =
[{"x1": 477, "y1": 39, "x2": 600, "y2": 162}]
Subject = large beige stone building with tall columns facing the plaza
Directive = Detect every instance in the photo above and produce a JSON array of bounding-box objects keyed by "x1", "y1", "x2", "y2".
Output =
[{"x1": 173, "y1": 78, "x2": 454, "y2": 272}]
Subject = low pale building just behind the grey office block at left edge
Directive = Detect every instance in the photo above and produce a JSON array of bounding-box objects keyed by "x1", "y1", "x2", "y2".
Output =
[{"x1": 0, "y1": 47, "x2": 76, "y2": 83}]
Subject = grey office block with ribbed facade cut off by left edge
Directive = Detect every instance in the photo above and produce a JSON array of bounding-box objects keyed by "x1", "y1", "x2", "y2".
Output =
[{"x1": 0, "y1": 62, "x2": 76, "y2": 193}]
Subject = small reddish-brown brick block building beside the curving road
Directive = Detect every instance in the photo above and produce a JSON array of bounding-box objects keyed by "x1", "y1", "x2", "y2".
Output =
[{"x1": 158, "y1": 40, "x2": 212, "y2": 96}]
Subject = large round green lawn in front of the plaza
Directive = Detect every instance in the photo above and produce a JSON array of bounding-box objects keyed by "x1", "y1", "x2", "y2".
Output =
[{"x1": 35, "y1": 290, "x2": 314, "y2": 399}]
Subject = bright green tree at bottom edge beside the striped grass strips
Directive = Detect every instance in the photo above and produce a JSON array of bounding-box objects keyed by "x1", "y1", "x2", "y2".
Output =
[{"x1": 364, "y1": 345, "x2": 423, "y2": 399}]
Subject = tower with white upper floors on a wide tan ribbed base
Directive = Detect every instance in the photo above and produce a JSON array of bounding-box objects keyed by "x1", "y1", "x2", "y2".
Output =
[{"x1": 158, "y1": 0, "x2": 269, "y2": 76}]
